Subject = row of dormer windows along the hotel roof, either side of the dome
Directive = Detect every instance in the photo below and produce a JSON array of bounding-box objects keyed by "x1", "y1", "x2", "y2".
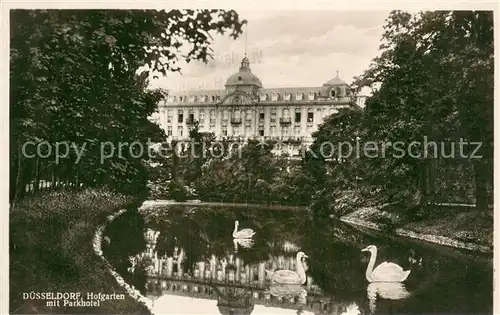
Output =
[{"x1": 168, "y1": 89, "x2": 337, "y2": 103}]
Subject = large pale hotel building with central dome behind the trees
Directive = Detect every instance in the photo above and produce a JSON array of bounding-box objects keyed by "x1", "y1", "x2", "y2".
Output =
[{"x1": 151, "y1": 56, "x2": 365, "y2": 154}]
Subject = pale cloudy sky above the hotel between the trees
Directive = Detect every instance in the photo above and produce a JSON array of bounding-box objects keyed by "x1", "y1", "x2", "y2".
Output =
[{"x1": 151, "y1": 10, "x2": 389, "y2": 91}]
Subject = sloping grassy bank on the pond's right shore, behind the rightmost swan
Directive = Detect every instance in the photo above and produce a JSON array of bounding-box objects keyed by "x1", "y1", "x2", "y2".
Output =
[{"x1": 342, "y1": 205, "x2": 493, "y2": 252}]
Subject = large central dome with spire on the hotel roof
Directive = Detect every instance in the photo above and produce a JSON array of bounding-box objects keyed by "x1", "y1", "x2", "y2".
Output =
[{"x1": 225, "y1": 56, "x2": 262, "y2": 98}]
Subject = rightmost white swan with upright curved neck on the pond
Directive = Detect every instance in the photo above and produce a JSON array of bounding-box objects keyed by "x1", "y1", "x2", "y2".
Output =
[{"x1": 361, "y1": 245, "x2": 411, "y2": 282}]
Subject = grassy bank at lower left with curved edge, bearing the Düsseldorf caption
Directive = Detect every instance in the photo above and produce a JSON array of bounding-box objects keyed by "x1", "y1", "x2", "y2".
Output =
[{"x1": 9, "y1": 190, "x2": 149, "y2": 314}]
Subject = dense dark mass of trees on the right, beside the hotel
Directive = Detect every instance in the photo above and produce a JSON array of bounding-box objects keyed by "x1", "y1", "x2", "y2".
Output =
[{"x1": 308, "y1": 11, "x2": 493, "y2": 217}]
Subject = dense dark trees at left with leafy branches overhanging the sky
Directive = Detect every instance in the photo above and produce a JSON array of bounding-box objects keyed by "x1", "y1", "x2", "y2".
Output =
[{"x1": 10, "y1": 10, "x2": 245, "y2": 199}]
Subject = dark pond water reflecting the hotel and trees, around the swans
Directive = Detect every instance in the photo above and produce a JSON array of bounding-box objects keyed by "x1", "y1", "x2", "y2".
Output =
[{"x1": 104, "y1": 206, "x2": 493, "y2": 315}]
